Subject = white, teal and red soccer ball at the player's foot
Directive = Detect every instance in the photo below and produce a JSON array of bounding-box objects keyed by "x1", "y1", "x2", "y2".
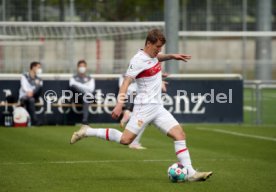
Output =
[{"x1": 168, "y1": 163, "x2": 188, "y2": 183}]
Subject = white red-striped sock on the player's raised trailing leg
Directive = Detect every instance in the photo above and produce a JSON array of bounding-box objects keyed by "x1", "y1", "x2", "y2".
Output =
[{"x1": 85, "y1": 128, "x2": 122, "y2": 143}]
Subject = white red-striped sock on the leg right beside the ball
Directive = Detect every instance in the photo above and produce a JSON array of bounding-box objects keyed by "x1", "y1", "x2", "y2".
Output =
[{"x1": 174, "y1": 140, "x2": 196, "y2": 176}]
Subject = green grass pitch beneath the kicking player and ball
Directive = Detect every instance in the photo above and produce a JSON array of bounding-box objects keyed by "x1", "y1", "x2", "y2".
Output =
[{"x1": 0, "y1": 124, "x2": 276, "y2": 192}]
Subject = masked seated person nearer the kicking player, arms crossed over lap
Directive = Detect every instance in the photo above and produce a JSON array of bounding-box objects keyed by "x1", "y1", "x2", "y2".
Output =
[{"x1": 69, "y1": 60, "x2": 95, "y2": 125}]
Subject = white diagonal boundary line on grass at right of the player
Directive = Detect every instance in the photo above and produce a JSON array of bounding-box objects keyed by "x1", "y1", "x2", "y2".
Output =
[{"x1": 196, "y1": 127, "x2": 276, "y2": 141}]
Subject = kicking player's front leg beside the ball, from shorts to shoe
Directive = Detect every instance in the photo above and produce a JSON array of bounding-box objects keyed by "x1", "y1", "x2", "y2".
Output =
[{"x1": 154, "y1": 108, "x2": 212, "y2": 181}]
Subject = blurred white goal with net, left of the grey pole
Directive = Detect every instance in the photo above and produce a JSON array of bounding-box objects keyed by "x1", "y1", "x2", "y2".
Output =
[{"x1": 0, "y1": 22, "x2": 164, "y2": 73}]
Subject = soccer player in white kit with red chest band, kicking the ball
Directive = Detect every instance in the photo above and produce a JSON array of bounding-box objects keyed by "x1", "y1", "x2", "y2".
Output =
[{"x1": 70, "y1": 29, "x2": 212, "y2": 181}]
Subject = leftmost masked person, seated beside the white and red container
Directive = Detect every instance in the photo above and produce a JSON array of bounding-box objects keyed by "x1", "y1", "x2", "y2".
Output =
[{"x1": 19, "y1": 61, "x2": 43, "y2": 125}]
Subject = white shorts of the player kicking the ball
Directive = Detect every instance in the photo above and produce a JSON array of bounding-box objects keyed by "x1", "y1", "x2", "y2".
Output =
[{"x1": 126, "y1": 104, "x2": 179, "y2": 135}]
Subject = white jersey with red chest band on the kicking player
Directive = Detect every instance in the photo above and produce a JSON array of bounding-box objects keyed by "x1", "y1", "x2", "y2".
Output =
[{"x1": 125, "y1": 50, "x2": 162, "y2": 104}]
